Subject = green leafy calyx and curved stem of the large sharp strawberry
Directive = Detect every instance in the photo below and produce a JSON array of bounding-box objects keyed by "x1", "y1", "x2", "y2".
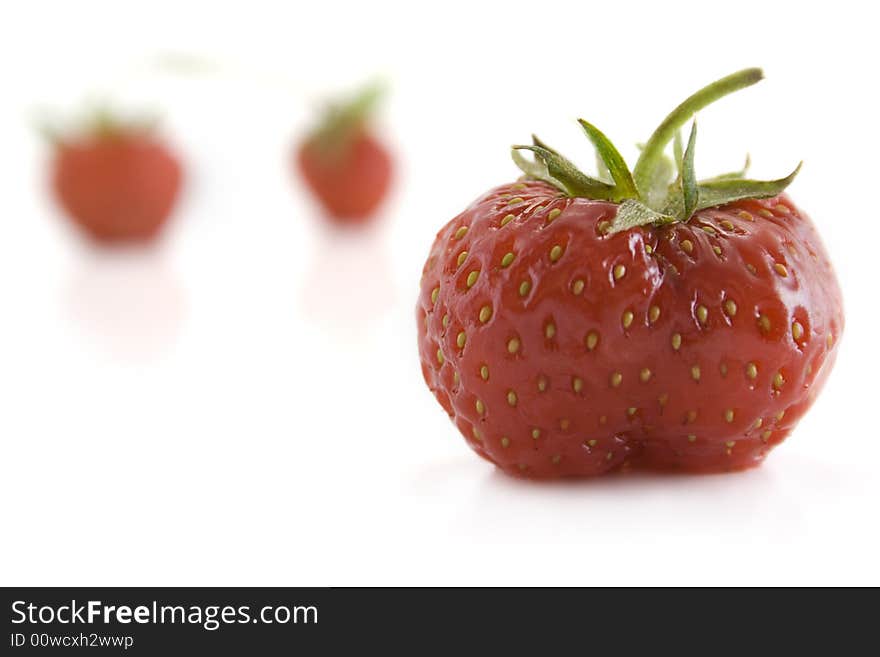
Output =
[{"x1": 511, "y1": 68, "x2": 801, "y2": 233}]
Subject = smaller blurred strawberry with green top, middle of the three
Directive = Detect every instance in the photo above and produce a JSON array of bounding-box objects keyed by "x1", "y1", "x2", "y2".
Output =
[{"x1": 296, "y1": 87, "x2": 392, "y2": 224}]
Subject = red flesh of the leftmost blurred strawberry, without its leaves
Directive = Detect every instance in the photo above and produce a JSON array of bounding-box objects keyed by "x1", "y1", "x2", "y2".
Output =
[{"x1": 52, "y1": 133, "x2": 182, "y2": 243}]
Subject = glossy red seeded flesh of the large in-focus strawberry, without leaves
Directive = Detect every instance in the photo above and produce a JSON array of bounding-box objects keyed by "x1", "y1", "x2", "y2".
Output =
[{"x1": 417, "y1": 182, "x2": 844, "y2": 478}]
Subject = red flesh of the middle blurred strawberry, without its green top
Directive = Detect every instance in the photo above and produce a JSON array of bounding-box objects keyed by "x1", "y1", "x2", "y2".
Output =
[{"x1": 297, "y1": 132, "x2": 392, "y2": 224}]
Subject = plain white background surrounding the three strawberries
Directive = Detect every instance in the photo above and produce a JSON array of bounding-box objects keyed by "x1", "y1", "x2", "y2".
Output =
[{"x1": 0, "y1": 1, "x2": 880, "y2": 584}]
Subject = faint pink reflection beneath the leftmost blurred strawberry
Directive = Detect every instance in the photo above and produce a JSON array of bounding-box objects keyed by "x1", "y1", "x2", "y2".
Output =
[{"x1": 64, "y1": 247, "x2": 187, "y2": 361}]
